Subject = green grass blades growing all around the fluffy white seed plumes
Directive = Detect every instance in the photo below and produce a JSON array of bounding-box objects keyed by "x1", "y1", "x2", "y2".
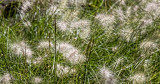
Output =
[{"x1": 0, "y1": 0, "x2": 160, "y2": 84}]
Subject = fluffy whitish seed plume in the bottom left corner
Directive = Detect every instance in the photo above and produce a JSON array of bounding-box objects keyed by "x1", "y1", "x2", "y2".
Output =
[{"x1": 0, "y1": 73, "x2": 12, "y2": 84}]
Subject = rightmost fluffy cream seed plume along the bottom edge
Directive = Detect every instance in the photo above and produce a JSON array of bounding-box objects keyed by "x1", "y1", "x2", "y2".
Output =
[{"x1": 131, "y1": 73, "x2": 146, "y2": 84}]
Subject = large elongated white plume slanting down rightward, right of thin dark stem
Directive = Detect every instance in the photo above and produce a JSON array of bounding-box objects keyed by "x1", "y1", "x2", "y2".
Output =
[{"x1": 57, "y1": 42, "x2": 86, "y2": 64}]
